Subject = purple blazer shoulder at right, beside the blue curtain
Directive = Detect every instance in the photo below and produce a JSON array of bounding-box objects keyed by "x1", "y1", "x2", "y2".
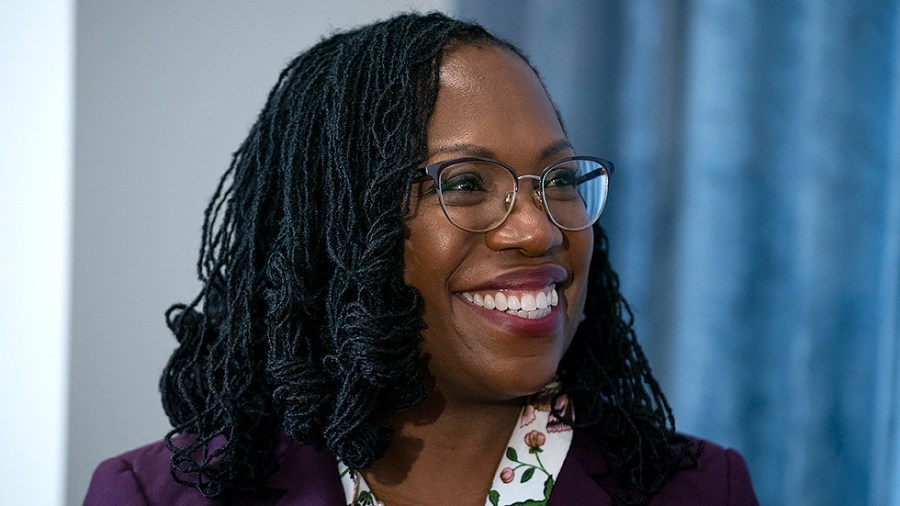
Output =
[{"x1": 650, "y1": 436, "x2": 758, "y2": 505}]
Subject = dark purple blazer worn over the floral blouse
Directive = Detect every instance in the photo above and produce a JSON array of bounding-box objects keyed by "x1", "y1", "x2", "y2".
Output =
[{"x1": 84, "y1": 430, "x2": 758, "y2": 506}]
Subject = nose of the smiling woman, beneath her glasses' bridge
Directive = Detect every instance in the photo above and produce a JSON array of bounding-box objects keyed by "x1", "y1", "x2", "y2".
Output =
[{"x1": 485, "y1": 182, "x2": 563, "y2": 256}]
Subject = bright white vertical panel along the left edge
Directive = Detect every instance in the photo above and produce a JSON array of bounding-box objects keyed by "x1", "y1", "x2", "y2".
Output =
[{"x1": 0, "y1": 0, "x2": 75, "y2": 505}]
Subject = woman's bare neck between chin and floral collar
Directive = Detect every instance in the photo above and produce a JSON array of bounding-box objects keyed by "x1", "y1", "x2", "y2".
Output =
[{"x1": 363, "y1": 391, "x2": 524, "y2": 506}]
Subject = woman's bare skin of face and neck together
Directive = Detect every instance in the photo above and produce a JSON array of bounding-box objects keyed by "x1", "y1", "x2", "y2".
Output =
[{"x1": 364, "y1": 45, "x2": 593, "y2": 506}]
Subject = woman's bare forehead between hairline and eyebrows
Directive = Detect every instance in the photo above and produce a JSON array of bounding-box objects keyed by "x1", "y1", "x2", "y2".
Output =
[{"x1": 428, "y1": 45, "x2": 565, "y2": 163}]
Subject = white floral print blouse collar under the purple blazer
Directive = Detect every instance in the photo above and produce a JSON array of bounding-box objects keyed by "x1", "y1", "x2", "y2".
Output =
[{"x1": 338, "y1": 381, "x2": 573, "y2": 506}]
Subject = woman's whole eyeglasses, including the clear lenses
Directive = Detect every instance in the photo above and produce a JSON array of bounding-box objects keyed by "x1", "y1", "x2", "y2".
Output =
[{"x1": 419, "y1": 156, "x2": 614, "y2": 232}]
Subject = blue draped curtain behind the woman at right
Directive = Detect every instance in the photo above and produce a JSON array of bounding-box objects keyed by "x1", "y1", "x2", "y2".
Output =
[{"x1": 457, "y1": 0, "x2": 900, "y2": 505}]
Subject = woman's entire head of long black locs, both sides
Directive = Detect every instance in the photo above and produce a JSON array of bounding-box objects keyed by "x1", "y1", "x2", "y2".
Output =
[{"x1": 160, "y1": 9, "x2": 696, "y2": 504}]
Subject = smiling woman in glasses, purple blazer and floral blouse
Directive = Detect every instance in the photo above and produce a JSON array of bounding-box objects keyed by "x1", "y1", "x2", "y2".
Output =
[{"x1": 86, "y1": 14, "x2": 755, "y2": 506}]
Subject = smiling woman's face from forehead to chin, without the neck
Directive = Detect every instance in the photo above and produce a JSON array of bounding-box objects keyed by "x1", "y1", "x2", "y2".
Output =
[{"x1": 404, "y1": 45, "x2": 593, "y2": 408}]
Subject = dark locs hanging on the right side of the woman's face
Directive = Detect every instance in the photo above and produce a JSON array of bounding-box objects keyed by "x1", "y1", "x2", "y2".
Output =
[{"x1": 558, "y1": 225, "x2": 703, "y2": 504}]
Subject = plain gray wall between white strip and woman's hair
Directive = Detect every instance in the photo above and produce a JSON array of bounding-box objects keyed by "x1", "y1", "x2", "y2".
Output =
[{"x1": 67, "y1": 0, "x2": 452, "y2": 505}]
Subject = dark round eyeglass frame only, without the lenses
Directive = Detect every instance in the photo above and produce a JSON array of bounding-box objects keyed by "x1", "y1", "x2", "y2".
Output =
[{"x1": 416, "y1": 156, "x2": 615, "y2": 233}]
